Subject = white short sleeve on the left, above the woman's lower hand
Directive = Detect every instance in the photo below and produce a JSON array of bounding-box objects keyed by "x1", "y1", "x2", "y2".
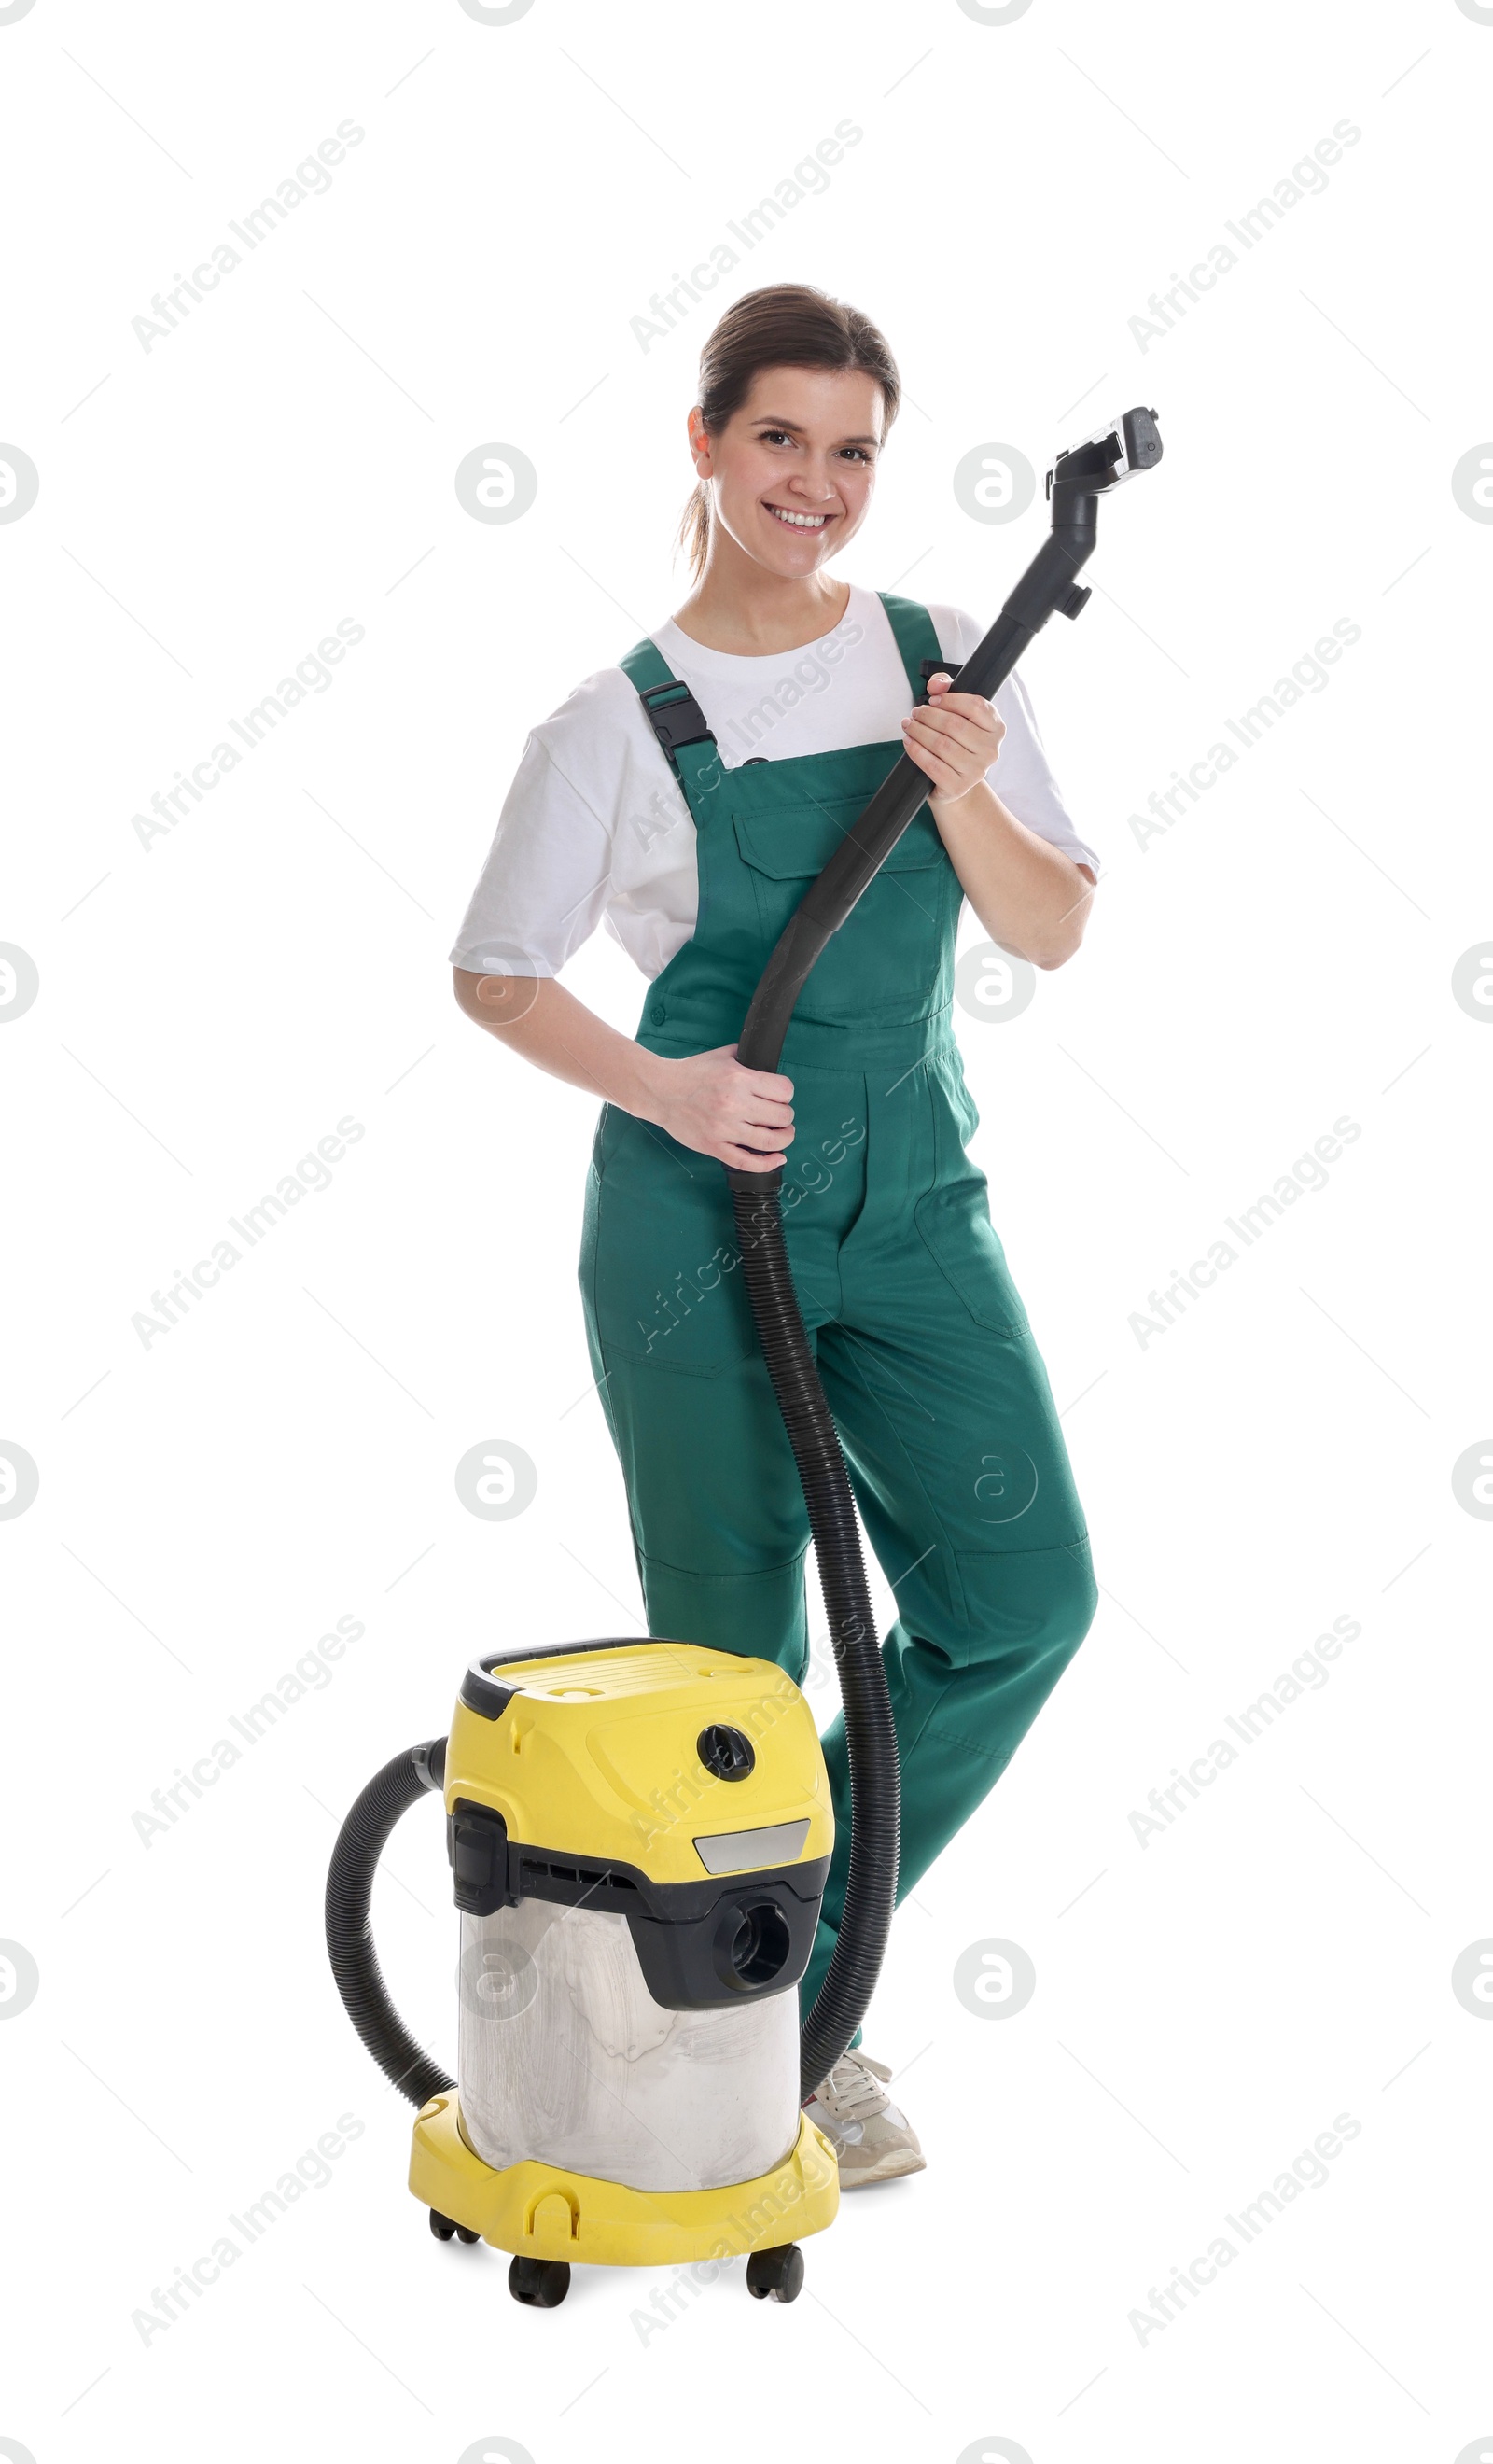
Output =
[{"x1": 451, "y1": 735, "x2": 613, "y2": 975}]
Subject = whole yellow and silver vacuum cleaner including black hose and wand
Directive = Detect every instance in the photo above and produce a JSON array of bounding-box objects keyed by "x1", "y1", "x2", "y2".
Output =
[{"x1": 326, "y1": 409, "x2": 1161, "y2": 2309}]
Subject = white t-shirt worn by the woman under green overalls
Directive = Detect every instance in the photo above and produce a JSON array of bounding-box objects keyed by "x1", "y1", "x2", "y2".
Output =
[{"x1": 451, "y1": 584, "x2": 1099, "y2": 978}]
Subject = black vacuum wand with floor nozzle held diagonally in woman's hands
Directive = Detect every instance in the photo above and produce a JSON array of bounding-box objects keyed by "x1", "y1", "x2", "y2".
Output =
[{"x1": 730, "y1": 409, "x2": 1161, "y2": 1088}]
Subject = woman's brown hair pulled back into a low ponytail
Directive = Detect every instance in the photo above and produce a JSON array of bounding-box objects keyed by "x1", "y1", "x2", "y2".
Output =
[{"x1": 677, "y1": 284, "x2": 901, "y2": 579}]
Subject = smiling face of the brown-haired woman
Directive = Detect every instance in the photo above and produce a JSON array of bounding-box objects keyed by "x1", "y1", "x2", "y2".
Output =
[{"x1": 690, "y1": 367, "x2": 885, "y2": 579}]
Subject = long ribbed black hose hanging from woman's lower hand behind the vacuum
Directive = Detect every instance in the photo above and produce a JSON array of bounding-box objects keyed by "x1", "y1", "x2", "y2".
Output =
[{"x1": 732, "y1": 1173, "x2": 901, "y2": 2097}]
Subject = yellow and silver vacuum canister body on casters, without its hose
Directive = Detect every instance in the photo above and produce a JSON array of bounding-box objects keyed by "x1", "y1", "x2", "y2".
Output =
[{"x1": 409, "y1": 1639, "x2": 840, "y2": 2306}]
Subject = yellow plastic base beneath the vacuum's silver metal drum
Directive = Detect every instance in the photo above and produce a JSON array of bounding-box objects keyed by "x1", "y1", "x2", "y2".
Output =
[{"x1": 409, "y1": 2094, "x2": 840, "y2": 2267}]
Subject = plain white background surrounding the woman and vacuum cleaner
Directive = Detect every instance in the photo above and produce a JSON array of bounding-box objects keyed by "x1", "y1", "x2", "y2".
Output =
[{"x1": 0, "y1": 0, "x2": 1493, "y2": 2464}]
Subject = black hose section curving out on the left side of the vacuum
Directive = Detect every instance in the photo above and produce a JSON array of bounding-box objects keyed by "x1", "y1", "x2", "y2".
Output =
[{"x1": 328, "y1": 1737, "x2": 455, "y2": 2105}]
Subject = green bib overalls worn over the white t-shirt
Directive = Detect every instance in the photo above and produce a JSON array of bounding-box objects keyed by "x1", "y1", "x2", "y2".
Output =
[{"x1": 581, "y1": 594, "x2": 1096, "y2": 2010}]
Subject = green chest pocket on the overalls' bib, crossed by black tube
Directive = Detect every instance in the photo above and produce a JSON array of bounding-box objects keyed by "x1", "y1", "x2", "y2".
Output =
[{"x1": 732, "y1": 789, "x2": 963, "y2": 1028}]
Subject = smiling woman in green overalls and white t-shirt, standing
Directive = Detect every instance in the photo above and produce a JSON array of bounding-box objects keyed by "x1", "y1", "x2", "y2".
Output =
[{"x1": 451, "y1": 284, "x2": 1096, "y2": 2188}]
